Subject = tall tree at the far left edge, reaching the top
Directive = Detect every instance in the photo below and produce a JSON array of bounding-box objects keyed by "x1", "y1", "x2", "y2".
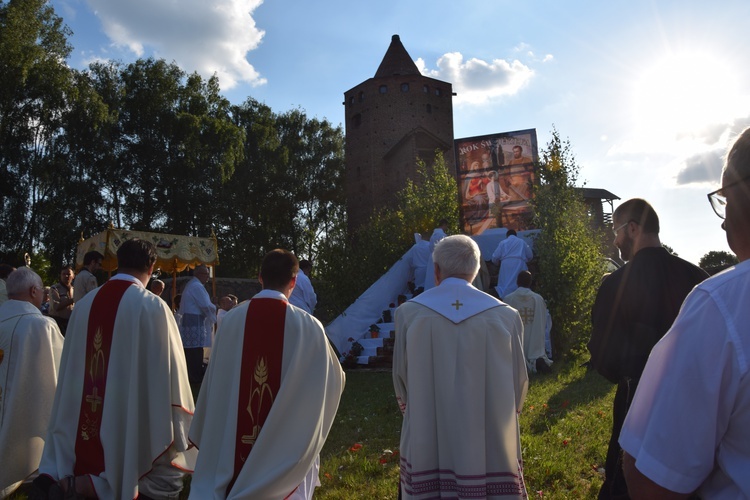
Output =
[{"x1": 0, "y1": 0, "x2": 72, "y2": 253}]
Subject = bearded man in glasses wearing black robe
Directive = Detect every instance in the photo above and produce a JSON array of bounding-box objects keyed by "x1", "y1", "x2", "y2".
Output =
[{"x1": 588, "y1": 198, "x2": 708, "y2": 499}]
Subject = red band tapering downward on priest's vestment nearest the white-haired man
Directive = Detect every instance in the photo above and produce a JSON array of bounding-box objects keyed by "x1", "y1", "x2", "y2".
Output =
[{"x1": 227, "y1": 299, "x2": 287, "y2": 496}]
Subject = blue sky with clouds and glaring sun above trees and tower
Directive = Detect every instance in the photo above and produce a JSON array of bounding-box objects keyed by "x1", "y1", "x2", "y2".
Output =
[{"x1": 52, "y1": 0, "x2": 750, "y2": 262}]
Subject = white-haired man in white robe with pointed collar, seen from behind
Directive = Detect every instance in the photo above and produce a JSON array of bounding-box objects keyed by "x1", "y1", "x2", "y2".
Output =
[{"x1": 393, "y1": 235, "x2": 528, "y2": 499}]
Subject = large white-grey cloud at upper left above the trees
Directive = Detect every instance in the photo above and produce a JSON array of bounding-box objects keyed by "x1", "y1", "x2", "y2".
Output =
[{"x1": 88, "y1": 0, "x2": 266, "y2": 90}]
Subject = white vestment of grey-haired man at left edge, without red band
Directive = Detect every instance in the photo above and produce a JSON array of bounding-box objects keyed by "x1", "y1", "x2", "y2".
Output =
[{"x1": 0, "y1": 300, "x2": 63, "y2": 498}]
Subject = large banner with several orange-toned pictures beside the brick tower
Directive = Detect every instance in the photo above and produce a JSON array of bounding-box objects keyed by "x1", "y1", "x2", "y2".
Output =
[{"x1": 454, "y1": 129, "x2": 539, "y2": 235}]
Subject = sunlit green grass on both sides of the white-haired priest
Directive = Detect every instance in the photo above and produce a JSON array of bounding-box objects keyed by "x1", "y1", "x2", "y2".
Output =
[{"x1": 11, "y1": 350, "x2": 614, "y2": 500}]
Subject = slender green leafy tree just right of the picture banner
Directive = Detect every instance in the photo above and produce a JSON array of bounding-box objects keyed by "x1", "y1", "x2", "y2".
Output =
[{"x1": 534, "y1": 129, "x2": 603, "y2": 353}]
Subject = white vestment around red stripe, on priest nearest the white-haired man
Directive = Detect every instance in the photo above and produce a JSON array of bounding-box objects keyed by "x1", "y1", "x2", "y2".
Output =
[{"x1": 190, "y1": 290, "x2": 345, "y2": 500}]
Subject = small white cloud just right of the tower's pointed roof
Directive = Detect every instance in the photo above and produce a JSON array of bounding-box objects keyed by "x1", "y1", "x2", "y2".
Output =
[{"x1": 416, "y1": 52, "x2": 534, "y2": 104}]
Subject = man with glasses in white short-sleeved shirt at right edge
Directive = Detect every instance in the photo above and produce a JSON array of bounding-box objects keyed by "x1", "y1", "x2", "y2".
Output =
[{"x1": 620, "y1": 129, "x2": 750, "y2": 499}]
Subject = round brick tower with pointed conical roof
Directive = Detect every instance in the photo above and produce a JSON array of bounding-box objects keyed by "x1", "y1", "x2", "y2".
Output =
[{"x1": 344, "y1": 35, "x2": 455, "y2": 230}]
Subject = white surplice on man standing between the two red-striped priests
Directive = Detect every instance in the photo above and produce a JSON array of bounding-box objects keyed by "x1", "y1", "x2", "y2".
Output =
[{"x1": 178, "y1": 277, "x2": 216, "y2": 348}]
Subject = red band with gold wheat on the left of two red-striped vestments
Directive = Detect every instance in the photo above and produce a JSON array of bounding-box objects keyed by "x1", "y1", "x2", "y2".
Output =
[{"x1": 73, "y1": 280, "x2": 133, "y2": 476}]
